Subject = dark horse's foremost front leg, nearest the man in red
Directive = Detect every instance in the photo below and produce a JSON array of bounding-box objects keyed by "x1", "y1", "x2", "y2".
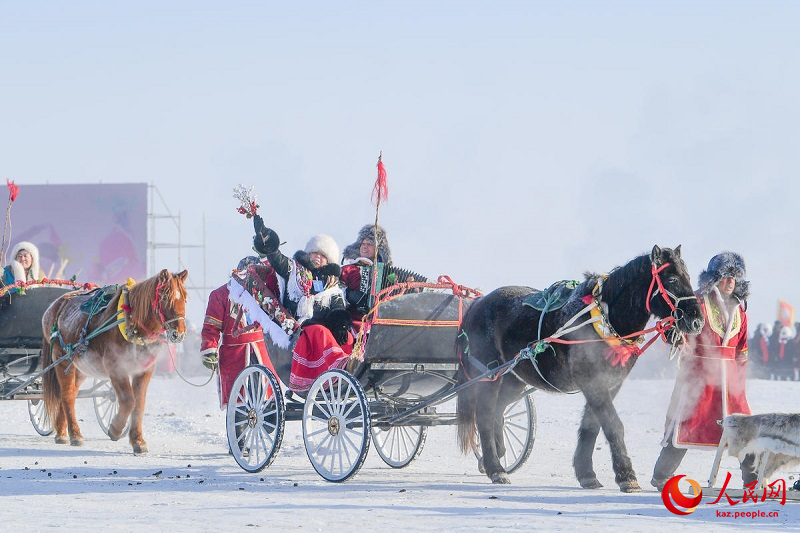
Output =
[{"x1": 576, "y1": 384, "x2": 642, "y2": 492}]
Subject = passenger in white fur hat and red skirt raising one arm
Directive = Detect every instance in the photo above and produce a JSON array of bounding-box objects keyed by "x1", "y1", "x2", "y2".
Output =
[{"x1": 253, "y1": 215, "x2": 354, "y2": 392}]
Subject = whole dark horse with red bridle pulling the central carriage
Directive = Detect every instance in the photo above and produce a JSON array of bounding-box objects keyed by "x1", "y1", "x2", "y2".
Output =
[{"x1": 458, "y1": 246, "x2": 705, "y2": 492}]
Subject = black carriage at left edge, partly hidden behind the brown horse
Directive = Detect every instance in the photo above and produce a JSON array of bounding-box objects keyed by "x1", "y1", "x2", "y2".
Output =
[{"x1": 0, "y1": 280, "x2": 118, "y2": 436}]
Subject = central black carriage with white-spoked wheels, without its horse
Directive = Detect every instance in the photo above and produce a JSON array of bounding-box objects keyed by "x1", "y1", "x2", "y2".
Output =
[{"x1": 226, "y1": 271, "x2": 536, "y2": 482}]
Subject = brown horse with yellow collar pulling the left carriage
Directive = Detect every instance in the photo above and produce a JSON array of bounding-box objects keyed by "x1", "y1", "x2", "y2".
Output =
[{"x1": 42, "y1": 269, "x2": 187, "y2": 453}]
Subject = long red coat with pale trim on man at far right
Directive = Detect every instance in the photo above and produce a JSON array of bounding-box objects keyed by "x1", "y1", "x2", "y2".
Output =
[{"x1": 665, "y1": 294, "x2": 750, "y2": 448}]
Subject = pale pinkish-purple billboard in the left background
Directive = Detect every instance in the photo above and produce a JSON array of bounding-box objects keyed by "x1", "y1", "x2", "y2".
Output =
[{"x1": 2, "y1": 183, "x2": 147, "y2": 285}]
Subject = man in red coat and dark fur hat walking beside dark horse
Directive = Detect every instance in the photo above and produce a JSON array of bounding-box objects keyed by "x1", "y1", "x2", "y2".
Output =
[{"x1": 650, "y1": 252, "x2": 756, "y2": 490}]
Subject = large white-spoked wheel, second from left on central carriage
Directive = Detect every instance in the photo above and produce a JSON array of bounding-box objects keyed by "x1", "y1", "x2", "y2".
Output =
[{"x1": 303, "y1": 369, "x2": 370, "y2": 482}]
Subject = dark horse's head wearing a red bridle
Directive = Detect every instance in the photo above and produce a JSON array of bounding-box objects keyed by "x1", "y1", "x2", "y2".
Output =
[{"x1": 647, "y1": 245, "x2": 706, "y2": 335}]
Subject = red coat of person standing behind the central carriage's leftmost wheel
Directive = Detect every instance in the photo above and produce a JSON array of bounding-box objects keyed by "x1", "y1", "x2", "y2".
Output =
[{"x1": 200, "y1": 285, "x2": 278, "y2": 407}]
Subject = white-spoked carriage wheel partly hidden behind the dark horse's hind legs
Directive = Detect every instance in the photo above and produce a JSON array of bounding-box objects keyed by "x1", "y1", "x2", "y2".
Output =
[{"x1": 475, "y1": 394, "x2": 536, "y2": 474}]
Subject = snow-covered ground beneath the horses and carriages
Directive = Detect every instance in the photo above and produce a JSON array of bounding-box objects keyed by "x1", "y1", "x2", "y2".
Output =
[{"x1": 0, "y1": 360, "x2": 800, "y2": 533}]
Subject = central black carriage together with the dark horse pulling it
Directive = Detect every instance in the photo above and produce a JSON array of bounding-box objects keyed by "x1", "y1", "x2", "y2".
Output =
[{"x1": 226, "y1": 246, "x2": 703, "y2": 492}]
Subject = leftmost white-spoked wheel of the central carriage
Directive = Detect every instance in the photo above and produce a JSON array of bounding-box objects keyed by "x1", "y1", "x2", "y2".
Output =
[{"x1": 225, "y1": 365, "x2": 286, "y2": 472}]
